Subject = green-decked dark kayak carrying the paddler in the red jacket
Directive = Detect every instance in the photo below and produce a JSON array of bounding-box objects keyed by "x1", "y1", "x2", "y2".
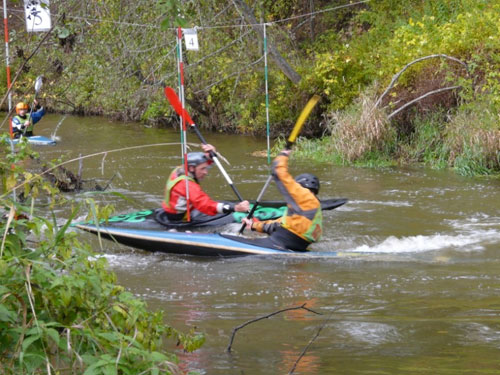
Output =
[{"x1": 73, "y1": 198, "x2": 347, "y2": 231}]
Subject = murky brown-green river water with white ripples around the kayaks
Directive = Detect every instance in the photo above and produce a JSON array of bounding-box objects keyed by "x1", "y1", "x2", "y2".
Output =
[{"x1": 31, "y1": 115, "x2": 500, "y2": 375}]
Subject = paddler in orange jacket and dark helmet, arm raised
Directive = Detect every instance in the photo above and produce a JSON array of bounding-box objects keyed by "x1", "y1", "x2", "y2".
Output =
[{"x1": 242, "y1": 150, "x2": 323, "y2": 251}]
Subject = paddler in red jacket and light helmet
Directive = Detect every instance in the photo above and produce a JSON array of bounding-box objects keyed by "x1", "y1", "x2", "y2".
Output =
[{"x1": 162, "y1": 144, "x2": 250, "y2": 221}]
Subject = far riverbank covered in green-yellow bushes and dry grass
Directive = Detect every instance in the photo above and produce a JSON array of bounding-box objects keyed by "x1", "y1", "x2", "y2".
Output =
[{"x1": 0, "y1": 0, "x2": 500, "y2": 175}]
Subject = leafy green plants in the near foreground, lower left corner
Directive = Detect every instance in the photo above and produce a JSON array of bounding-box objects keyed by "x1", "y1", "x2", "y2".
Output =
[{"x1": 0, "y1": 140, "x2": 202, "y2": 375}]
